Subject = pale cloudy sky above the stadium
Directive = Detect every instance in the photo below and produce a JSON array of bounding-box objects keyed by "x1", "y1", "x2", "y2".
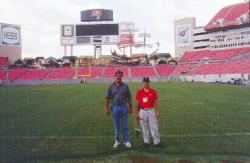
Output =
[{"x1": 0, "y1": 0, "x2": 244, "y2": 58}]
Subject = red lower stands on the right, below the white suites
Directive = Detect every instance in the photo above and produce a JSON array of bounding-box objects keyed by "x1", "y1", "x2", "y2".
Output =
[{"x1": 176, "y1": 48, "x2": 250, "y2": 83}]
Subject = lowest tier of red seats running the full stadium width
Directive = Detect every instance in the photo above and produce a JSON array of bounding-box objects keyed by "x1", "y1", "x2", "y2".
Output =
[{"x1": 0, "y1": 59, "x2": 250, "y2": 81}]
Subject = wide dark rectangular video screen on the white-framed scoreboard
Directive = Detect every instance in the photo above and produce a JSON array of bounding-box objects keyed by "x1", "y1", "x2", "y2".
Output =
[{"x1": 76, "y1": 24, "x2": 119, "y2": 36}]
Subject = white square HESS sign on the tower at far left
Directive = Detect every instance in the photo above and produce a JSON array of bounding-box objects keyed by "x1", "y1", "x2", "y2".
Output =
[{"x1": 2, "y1": 26, "x2": 20, "y2": 45}]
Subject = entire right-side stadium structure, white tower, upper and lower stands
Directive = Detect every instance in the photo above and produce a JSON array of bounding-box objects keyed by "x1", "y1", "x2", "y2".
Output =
[{"x1": 175, "y1": 2, "x2": 250, "y2": 83}]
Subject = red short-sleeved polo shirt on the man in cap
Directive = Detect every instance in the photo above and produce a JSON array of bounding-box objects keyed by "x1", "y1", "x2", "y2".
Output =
[{"x1": 136, "y1": 88, "x2": 158, "y2": 108}]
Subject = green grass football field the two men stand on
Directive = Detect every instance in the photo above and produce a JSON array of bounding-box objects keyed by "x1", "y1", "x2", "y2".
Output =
[{"x1": 0, "y1": 82, "x2": 250, "y2": 162}]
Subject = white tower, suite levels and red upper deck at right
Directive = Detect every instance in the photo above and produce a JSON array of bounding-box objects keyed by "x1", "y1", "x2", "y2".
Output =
[{"x1": 174, "y1": 2, "x2": 250, "y2": 58}]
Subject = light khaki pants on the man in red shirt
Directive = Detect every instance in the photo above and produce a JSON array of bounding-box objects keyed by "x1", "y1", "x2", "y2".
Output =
[{"x1": 139, "y1": 108, "x2": 160, "y2": 145}]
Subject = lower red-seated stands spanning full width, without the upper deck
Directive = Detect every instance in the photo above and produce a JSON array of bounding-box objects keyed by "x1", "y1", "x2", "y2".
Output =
[{"x1": 0, "y1": 45, "x2": 250, "y2": 84}]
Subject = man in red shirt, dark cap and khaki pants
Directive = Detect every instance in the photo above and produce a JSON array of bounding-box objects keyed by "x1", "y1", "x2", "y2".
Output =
[{"x1": 135, "y1": 77, "x2": 161, "y2": 147}]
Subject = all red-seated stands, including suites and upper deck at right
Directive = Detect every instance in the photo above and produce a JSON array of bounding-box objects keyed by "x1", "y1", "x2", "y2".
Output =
[{"x1": 0, "y1": 2, "x2": 250, "y2": 84}]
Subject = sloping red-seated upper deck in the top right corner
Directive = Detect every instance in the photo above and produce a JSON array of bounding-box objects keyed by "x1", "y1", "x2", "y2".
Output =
[{"x1": 205, "y1": 2, "x2": 250, "y2": 30}]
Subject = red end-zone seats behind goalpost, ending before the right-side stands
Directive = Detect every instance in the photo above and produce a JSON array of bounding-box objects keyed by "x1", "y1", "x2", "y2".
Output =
[{"x1": 2, "y1": 65, "x2": 175, "y2": 81}]
